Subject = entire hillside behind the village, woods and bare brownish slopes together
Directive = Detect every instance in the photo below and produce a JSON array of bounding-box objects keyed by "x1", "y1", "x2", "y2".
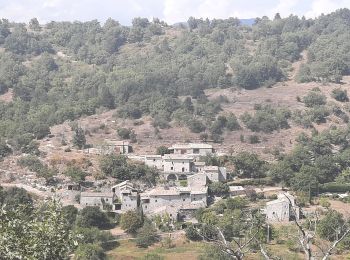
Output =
[{"x1": 0, "y1": 9, "x2": 350, "y2": 181}]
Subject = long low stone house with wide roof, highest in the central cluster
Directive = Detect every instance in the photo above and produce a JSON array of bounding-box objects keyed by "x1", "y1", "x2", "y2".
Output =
[{"x1": 168, "y1": 143, "x2": 215, "y2": 156}]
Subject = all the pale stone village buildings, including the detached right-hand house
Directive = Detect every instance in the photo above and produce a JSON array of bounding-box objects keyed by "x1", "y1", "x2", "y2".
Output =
[{"x1": 80, "y1": 142, "x2": 299, "y2": 222}]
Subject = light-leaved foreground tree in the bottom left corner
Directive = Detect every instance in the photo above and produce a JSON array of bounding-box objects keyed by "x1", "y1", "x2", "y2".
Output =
[{"x1": 0, "y1": 201, "x2": 77, "y2": 260}]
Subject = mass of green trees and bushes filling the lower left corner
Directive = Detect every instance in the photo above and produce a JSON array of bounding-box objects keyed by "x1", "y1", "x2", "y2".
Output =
[{"x1": 0, "y1": 187, "x2": 116, "y2": 260}]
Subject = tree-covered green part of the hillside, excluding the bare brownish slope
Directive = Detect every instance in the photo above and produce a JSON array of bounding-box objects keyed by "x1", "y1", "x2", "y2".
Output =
[{"x1": 0, "y1": 9, "x2": 350, "y2": 156}]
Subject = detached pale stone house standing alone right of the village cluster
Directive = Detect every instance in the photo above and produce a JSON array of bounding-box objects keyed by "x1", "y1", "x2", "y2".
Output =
[{"x1": 265, "y1": 193, "x2": 300, "y2": 221}]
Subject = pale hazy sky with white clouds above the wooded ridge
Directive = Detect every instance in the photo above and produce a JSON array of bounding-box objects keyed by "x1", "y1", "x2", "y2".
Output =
[{"x1": 0, "y1": 0, "x2": 350, "y2": 25}]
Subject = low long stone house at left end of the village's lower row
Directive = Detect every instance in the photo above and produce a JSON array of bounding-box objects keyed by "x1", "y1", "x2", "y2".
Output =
[{"x1": 80, "y1": 192, "x2": 115, "y2": 210}]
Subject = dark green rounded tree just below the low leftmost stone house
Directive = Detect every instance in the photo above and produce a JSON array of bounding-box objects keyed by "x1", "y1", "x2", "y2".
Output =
[{"x1": 77, "y1": 206, "x2": 111, "y2": 228}]
